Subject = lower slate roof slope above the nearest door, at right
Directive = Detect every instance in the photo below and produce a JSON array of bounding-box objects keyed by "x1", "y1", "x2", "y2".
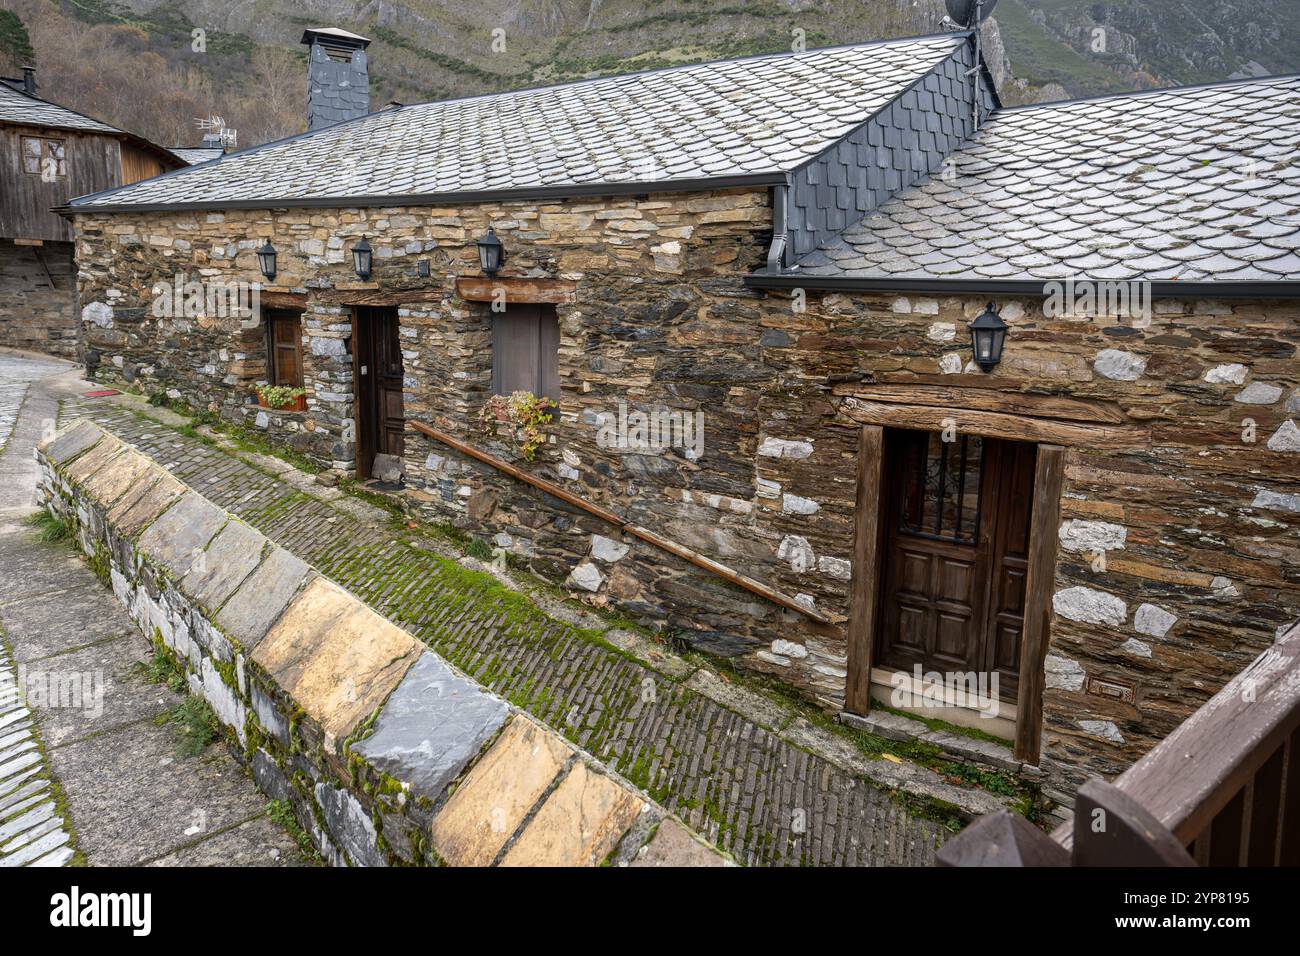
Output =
[{"x1": 787, "y1": 77, "x2": 1300, "y2": 282}]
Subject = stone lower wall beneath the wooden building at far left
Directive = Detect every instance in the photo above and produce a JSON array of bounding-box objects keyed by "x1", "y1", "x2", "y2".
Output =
[{"x1": 0, "y1": 239, "x2": 78, "y2": 359}]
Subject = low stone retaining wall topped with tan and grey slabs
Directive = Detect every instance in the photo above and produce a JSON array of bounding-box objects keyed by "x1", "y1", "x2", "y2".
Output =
[{"x1": 38, "y1": 421, "x2": 723, "y2": 866}]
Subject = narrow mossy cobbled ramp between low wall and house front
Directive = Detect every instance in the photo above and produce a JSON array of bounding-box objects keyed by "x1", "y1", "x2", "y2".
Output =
[{"x1": 62, "y1": 401, "x2": 946, "y2": 865}]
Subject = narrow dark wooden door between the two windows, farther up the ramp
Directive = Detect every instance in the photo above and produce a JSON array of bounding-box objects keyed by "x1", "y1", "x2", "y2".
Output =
[{"x1": 352, "y1": 306, "x2": 406, "y2": 479}]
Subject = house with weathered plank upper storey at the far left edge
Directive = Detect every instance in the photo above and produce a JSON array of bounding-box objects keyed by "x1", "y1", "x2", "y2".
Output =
[{"x1": 0, "y1": 68, "x2": 187, "y2": 358}]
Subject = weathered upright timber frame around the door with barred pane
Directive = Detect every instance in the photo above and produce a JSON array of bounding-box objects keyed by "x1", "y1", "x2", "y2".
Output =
[{"x1": 844, "y1": 421, "x2": 1065, "y2": 765}]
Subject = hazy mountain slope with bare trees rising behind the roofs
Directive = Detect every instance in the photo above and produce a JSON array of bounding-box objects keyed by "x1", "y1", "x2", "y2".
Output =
[{"x1": 0, "y1": 0, "x2": 1300, "y2": 146}]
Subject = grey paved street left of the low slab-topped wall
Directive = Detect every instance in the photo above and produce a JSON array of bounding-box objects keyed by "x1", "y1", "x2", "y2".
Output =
[{"x1": 0, "y1": 351, "x2": 303, "y2": 868}]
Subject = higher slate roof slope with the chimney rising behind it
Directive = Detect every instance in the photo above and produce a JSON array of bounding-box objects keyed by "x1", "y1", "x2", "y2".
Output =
[{"x1": 73, "y1": 33, "x2": 969, "y2": 208}]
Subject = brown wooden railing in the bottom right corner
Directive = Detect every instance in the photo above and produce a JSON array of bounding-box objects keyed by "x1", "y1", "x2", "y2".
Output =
[{"x1": 937, "y1": 624, "x2": 1300, "y2": 866}]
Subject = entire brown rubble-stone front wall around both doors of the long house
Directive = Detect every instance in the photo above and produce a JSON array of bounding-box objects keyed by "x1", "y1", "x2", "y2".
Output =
[{"x1": 68, "y1": 191, "x2": 1300, "y2": 806}]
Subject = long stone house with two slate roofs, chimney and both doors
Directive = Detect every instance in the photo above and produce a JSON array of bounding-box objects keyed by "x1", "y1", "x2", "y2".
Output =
[{"x1": 64, "y1": 31, "x2": 1300, "y2": 799}]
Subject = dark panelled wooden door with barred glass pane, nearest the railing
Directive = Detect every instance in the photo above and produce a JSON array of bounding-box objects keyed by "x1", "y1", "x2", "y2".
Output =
[{"x1": 875, "y1": 431, "x2": 1035, "y2": 700}]
